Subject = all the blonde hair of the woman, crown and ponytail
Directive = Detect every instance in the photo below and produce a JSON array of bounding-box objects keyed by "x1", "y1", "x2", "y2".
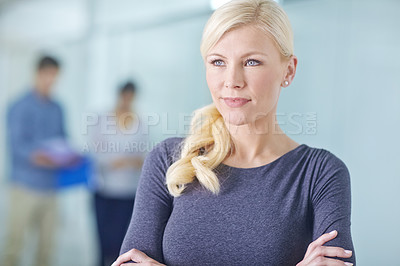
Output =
[{"x1": 166, "y1": 0, "x2": 293, "y2": 197}]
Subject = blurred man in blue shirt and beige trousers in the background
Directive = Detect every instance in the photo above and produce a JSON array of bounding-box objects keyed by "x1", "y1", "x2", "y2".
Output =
[{"x1": 0, "y1": 56, "x2": 65, "y2": 266}]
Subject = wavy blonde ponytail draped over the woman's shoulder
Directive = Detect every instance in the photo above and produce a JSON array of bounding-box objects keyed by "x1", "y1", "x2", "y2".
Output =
[{"x1": 166, "y1": 104, "x2": 232, "y2": 197}]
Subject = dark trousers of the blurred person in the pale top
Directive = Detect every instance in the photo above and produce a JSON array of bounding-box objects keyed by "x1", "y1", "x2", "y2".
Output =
[{"x1": 94, "y1": 193, "x2": 134, "y2": 266}]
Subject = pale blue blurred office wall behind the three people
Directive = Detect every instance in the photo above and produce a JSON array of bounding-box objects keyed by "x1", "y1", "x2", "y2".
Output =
[{"x1": 0, "y1": 0, "x2": 400, "y2": 266}]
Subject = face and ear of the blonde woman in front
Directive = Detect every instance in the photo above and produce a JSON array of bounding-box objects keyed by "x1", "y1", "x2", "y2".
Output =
[{"x1": 205, "y1": 26, "x2": 297, "y2": 126}]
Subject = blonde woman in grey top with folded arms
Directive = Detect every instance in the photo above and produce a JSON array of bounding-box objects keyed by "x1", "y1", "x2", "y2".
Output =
[{"x1": 113, "y1": 0, "x2": 355, "y2": 266}]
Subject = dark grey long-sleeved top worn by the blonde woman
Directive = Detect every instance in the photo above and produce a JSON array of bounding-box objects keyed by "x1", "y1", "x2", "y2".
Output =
[{"x1": 121, "y1": 138, "x2": 355, "y2": 266}]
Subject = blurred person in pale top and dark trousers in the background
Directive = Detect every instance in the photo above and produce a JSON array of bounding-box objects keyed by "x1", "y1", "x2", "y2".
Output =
[{"x1": 89, "y1": 82, "x2": 148, "y2": 266}]
